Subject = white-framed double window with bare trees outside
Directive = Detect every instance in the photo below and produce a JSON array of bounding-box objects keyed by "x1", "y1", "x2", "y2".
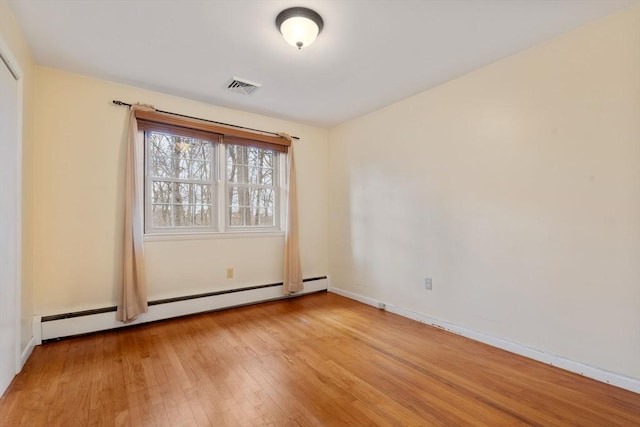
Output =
[{"x1": 144, "y1": 121, "x2": 285, "y2": 234}]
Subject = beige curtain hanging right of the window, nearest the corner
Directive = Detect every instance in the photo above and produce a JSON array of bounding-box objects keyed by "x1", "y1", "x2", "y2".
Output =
[{"x1": 282, "y1": 140, "x2": 303, "y2": 294}]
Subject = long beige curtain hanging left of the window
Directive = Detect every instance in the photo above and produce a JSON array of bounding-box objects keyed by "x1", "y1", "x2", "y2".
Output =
[{"x1": 117, "y1": 105, "x2": 153, "y2": 322}]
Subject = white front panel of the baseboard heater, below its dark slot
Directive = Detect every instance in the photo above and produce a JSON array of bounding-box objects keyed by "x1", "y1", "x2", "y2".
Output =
[{"x1": 34, "y1": 278, "x2": 329, "y2": 343}]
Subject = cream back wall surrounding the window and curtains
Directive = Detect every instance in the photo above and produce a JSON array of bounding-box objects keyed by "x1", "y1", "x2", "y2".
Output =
[{"x1": 33, "y1": 67, "x2": 328, "y2": 314}]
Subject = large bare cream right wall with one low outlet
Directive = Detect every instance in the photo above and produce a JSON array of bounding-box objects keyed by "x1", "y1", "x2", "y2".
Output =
[{"x1": 329, "y1": 7, "x2": 640, "y2": 378}]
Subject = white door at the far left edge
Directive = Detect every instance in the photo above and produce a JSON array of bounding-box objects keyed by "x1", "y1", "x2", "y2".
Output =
[{"x1": 0, "y1": 46, "x2": 21, "y2": 395}]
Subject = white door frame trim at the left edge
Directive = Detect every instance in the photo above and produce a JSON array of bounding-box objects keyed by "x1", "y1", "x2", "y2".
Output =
[{"x1": 0, "y1": 34, "x2": 24, "y2": 384}]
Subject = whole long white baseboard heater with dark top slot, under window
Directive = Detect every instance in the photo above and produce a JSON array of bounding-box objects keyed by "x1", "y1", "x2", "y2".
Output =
[{"x1": 34, "y1": 276, "x2": 329, "y2": 344}]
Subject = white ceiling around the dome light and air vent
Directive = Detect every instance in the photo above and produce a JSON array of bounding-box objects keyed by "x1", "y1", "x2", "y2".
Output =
[{"x1": 8, "y1": 0, "x2": 638, "y2": 127}]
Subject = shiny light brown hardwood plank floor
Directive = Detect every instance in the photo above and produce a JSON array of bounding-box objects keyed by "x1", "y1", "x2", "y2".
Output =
[{"x1": 0, "y1": 293, "x2": 640, "y2": 426}]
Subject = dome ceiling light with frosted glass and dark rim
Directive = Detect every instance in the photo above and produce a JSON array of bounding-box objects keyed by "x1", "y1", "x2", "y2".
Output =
[{"x1": 276, "y1": 7, "x2": 324, "y2": 49}]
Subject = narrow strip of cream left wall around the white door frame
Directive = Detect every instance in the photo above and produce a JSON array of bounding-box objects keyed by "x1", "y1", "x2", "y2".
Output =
[{"x1": 0, "y1": 0, "x2": 35, "y2": 350}]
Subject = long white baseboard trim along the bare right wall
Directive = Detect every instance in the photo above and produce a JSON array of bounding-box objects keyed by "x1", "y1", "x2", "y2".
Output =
[{"x1": 329, "y1": 287, "x2": 640, "y2": 393}]
